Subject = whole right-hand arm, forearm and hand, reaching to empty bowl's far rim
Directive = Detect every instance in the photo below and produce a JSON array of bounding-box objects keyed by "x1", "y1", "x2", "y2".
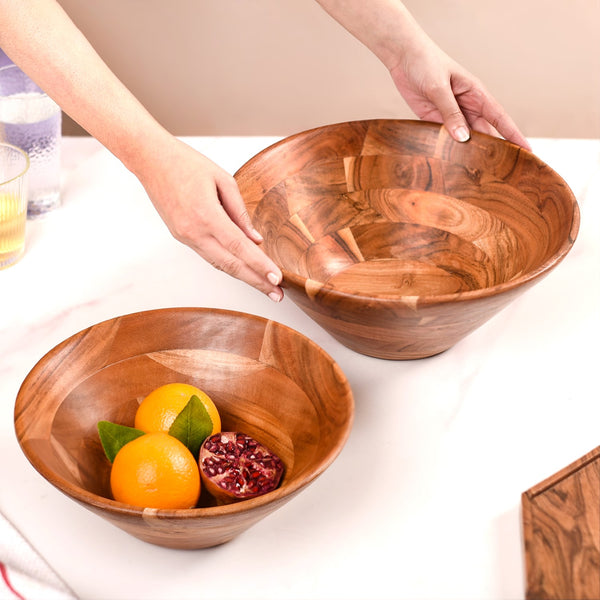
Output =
[{"x1": 317, "y1": 0, "x2": 529, "y2": 149}]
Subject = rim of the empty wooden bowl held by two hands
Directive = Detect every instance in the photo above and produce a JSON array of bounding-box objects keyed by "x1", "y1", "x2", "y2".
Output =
[{"x1": 234, "y1": 119, "x2": 580, "y2": 305}]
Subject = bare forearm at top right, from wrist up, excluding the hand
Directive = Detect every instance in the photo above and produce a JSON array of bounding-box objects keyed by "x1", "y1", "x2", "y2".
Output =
[{"x1": 316, "y1": 0, "x2": 431, "y2": 70}]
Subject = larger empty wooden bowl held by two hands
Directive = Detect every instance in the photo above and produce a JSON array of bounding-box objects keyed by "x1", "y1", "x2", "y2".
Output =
[{"x1": 235, "y1": 120, "x2": 579, "y2": 359}]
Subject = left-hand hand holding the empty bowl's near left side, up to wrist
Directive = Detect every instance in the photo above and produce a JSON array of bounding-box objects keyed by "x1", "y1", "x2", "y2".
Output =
[{"x1": 137, "y1": 138, "x2": 283, "y2": 302}]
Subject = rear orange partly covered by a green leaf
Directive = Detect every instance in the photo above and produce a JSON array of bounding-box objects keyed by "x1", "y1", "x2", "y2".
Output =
[{"x1": 134, "y1": 383, "x2": 221, "y2": 435}]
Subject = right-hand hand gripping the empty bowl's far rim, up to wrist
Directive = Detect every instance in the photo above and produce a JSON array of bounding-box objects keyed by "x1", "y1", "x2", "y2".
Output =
[{"x1": 390, "y1": 36, "x2": 531, "y2": 150}]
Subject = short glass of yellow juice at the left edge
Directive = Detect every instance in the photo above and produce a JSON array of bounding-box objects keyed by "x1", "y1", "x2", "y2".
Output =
[{"x1": 0, "y1": 142, "x2": 29, "y2": 269}]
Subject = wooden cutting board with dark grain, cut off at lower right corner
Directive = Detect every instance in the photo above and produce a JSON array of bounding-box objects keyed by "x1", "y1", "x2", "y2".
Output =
[{"x1": 521, "y1": 446, "x2": 600, "y2": 600}]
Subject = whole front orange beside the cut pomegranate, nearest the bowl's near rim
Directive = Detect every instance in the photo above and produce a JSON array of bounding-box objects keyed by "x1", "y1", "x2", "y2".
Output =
[{"x1": 110, "y1": 432, "x2": 200, "y2": 508}]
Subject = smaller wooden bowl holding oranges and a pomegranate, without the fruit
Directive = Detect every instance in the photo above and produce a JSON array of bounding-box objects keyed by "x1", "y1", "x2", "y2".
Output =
[{"x1": 15, "y1": 308, "x2": 354, "y2": 548}]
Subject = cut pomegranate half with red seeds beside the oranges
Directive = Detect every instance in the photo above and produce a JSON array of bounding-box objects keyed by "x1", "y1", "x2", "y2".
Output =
[{"x1": 198, "y1": 431, "x2": 284, "y2": 502}]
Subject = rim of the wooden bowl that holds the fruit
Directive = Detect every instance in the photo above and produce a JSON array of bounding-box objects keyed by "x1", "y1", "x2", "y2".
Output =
[{"x1": 14, "y1": 307, "x2": 354, "y2": 520}]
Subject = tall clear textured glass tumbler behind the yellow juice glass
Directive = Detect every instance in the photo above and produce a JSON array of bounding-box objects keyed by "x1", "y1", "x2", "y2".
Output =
[{"x1": 0, "y1": 64, "x2": 62, "y2": 218}]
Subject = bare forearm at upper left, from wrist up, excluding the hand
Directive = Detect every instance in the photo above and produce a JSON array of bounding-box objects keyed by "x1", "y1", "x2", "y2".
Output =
[{"x1": 0, "y1": 0, "x2": 168, "y2": 177}]
